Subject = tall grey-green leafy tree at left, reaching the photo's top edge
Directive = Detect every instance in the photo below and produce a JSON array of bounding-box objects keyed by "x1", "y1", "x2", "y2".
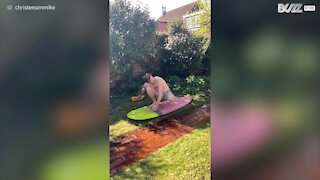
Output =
[{"x1": 109, "y1": 0, "x2": 156, "y2": 79}]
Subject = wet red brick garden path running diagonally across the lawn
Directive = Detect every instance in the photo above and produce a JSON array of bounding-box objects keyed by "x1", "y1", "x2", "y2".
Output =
[{"x1": 110, "y1": 105, "x2": 210, "y2": 176}]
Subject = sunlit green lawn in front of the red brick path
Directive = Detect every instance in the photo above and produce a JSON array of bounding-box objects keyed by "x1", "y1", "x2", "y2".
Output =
[{"x1": 112, "y1": 124, "x2": 210, "y2": 180}]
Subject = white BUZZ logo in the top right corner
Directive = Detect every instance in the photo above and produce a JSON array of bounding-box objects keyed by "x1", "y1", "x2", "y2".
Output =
[{"x1": 278, "y1": 3, "x2": 316, "y2": 14}]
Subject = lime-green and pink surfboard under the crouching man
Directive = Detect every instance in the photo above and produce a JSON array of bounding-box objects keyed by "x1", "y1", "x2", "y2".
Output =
[{"x1": 127, "y1": 96, "x2": 192, "y2": 120}]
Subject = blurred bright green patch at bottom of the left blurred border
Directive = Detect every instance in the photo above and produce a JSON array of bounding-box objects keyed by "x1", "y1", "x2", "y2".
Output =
[{"x1": 38, "y1": 140, "x2": 109, "y2": 180}]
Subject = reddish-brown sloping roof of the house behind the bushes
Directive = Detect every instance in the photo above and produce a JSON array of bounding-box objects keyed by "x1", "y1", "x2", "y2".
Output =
[{"x1": 157, "y1": 2, "x2": 196, "y2": 22}]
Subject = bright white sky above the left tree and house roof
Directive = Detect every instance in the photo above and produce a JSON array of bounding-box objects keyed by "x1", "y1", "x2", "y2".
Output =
[{"x1": 111, "y1": 0, "x2": 196, "y2": 19}]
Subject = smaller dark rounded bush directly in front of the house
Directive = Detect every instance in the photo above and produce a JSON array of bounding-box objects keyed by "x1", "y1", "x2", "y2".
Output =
[{"x1": 159, "y1": 22, "x2": 204, "y2": 78}]
